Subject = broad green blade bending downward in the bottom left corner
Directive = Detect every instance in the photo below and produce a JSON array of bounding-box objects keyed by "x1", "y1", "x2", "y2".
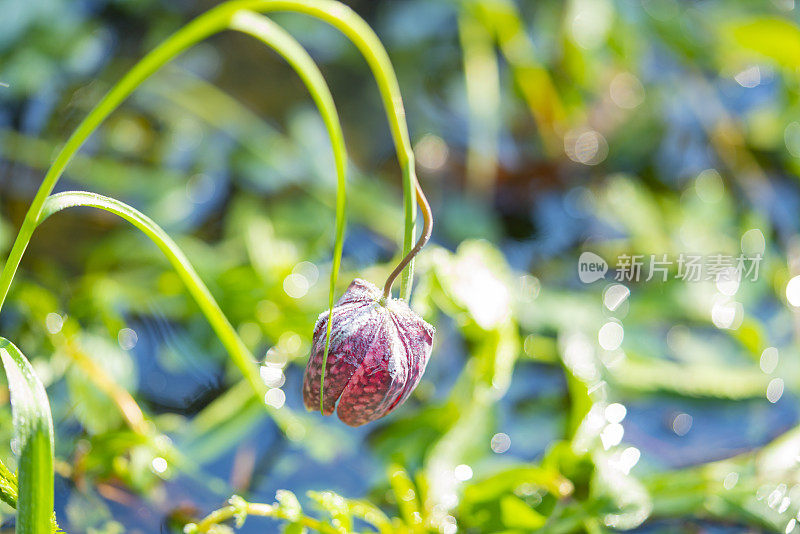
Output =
[{"x1": 0, "y1": 338, "x2": 54, "y2": 534}]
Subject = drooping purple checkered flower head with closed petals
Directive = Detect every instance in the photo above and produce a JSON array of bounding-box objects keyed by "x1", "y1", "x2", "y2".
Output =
[{"x1": 303, "y1": 278, "x2": 434, "y2": 426}]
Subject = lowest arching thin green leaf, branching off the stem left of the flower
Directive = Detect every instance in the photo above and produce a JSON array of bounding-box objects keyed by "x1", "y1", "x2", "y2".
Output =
[{"x1": 36, "y1": 191, "x2": 266, "y2": 410}]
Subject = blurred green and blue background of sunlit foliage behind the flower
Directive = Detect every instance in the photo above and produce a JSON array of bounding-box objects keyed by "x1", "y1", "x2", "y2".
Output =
[{"x1": 0, "y1": 0, "x2": 800, "y2": 534}]
